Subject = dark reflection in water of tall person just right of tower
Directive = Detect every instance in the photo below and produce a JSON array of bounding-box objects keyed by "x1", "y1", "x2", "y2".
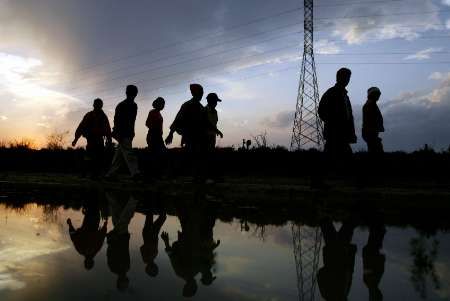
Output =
[{"x1": 317, "y1": 219, "x2": 356, "y2": 301}]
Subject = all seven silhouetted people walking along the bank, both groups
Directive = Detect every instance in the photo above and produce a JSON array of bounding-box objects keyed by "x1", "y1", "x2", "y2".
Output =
[{"x1": 72, "y1": 68, "x2": 384, "y2": 179}]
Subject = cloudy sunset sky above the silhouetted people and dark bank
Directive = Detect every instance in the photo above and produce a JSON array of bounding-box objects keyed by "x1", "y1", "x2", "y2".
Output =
[{"x1": 0, "y1": 0, "x2": 450, "y2": 151}]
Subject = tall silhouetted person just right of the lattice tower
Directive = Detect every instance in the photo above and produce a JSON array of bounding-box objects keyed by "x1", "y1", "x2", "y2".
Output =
[{"x1": 319, "y1": 68, "x2": 357, "y2": 157}]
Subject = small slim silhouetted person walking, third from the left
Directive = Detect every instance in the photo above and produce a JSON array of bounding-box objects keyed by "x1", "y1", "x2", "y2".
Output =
[{"x1": 145, "y1": 97, "x2": 166, "y2": 176}]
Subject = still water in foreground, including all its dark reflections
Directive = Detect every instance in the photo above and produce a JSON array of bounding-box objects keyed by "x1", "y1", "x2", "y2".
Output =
[{"x1": 0, "y1": 193, "x2": 450, "y2": 301}]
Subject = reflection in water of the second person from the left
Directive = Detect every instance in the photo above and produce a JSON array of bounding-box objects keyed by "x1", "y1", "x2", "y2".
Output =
[{"x1": 106, "y1": 193, "x2": 138, "y2": 291}]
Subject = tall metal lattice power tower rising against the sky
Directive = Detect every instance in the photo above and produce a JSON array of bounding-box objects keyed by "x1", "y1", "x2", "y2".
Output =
[{"x1": 291, "y1": 0, "x2": 323, "y2": 151}]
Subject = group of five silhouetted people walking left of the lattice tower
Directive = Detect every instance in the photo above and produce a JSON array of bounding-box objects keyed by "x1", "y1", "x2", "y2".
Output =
[{"x1": 72, "y1": 84, "x2": 223, "y2": 179}]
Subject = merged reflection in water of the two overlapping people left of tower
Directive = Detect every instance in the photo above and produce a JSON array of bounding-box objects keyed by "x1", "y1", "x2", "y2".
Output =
[{"x1": 161, "y1": 200, "x2": 220, "y2": 297}]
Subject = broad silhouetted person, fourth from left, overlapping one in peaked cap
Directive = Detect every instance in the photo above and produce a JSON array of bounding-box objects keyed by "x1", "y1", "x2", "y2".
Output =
[{"x1": 165, "y1": 84, "x2": 208, "y2": 179}]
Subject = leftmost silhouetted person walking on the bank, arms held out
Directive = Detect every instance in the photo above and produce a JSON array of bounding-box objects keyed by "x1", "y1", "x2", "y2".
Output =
[{"x1": 72, "y1": 98, "x2": 111, "y2": 177}]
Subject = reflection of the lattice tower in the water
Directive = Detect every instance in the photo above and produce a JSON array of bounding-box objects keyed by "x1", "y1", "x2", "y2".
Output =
[{"x1": 291, "y1": 223, "x2": 322, "y2": 301}]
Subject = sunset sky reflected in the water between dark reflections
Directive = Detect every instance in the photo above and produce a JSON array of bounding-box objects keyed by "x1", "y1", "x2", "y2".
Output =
[{"x1": 0, "y1": 205, "x2": 450, "y2": 301}]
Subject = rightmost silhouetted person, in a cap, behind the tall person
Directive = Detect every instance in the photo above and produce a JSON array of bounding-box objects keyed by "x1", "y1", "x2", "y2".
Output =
[{"x1": 362, "y1": 87, "x2": 384, "y2": 153}]
